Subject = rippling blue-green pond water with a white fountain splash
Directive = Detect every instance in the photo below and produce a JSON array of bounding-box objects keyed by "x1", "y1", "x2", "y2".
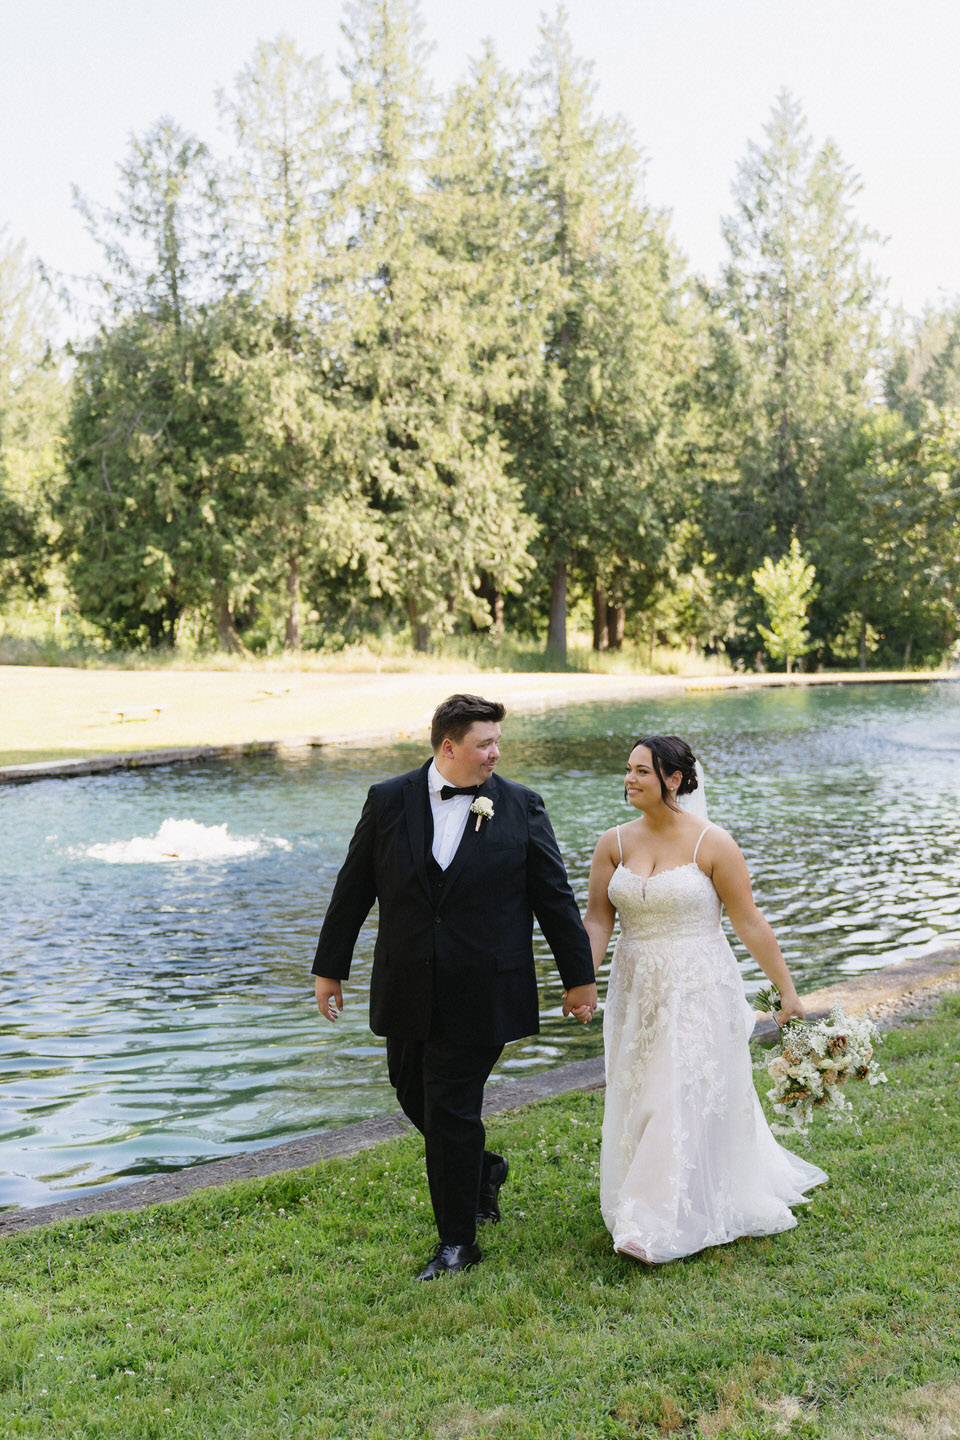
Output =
[{"x1": 0, "y1": 684, "x2": 960, "y2": 1207}]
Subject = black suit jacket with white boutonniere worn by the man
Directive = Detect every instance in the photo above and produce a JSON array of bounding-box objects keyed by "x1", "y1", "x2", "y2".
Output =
[{"x1": 314, "y1": 760, "x2": 594, "y2": 1045}]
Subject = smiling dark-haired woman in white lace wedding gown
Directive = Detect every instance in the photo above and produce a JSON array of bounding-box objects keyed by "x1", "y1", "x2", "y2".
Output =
[{"x1": 574, "y1": 736, "x2": 826, "y2": 1264}]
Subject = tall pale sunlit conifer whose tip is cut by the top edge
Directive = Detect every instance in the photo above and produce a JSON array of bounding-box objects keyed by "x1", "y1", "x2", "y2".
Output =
[{"x1": 336, "y1": 0, "x2": 533, "y2": 649}]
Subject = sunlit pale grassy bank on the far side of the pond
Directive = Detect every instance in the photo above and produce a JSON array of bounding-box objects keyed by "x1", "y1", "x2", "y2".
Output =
[{"x1": 0, "y1": 665, "x2": 960, "y2": 785}]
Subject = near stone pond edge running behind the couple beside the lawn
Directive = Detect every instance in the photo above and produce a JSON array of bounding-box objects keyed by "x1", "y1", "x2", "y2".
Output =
[{"x1": 0, "y1": 945, "x2": 960, "y2": 1236}]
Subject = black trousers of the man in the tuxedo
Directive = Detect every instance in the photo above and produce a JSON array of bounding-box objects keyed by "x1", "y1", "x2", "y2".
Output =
[{"x1": 387, "y1": 1025, "x2": 502, "y2": 1246}]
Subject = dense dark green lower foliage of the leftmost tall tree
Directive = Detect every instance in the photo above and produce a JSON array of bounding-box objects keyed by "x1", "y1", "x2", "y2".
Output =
[{"x1": 59, "y1": 312, "x2": 266, "y2": 649}]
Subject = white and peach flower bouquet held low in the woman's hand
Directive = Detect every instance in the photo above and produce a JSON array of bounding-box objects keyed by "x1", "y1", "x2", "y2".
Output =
[{"x1": 753, "y1": 985, "x2": 887, "y2": 1135}]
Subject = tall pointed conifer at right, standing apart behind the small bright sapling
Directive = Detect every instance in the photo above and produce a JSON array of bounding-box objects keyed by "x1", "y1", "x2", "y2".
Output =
[{"x1": 705, "y1": 92, "x2": 878, "y2": 590}]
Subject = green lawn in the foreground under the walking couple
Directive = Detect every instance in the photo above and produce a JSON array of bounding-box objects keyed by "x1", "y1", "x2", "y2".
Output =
[{"x1": 0, "y1": 998, "x2": 960, "y2": 1440}]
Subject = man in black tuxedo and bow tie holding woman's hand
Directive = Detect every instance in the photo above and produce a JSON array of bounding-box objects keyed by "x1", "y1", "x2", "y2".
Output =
[{"x1": 314, "y1": 696, "x2": 597, "y2": 1280}]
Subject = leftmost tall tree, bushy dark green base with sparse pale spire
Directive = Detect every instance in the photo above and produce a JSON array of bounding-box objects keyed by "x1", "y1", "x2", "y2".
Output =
[{"x1": 58, "y1": 121, "x2": 263, "y2": 649}]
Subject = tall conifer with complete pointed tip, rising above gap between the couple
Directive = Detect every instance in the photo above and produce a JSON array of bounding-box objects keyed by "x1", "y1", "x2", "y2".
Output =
[{"x1": 510, "y1": 9, "x2": 690, "y2": 662}]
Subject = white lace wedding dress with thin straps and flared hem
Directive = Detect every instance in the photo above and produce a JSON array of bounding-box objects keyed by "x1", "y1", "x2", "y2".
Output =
[{"x1": 600, "y1": 825, "x2": 826, "y2": 1263}]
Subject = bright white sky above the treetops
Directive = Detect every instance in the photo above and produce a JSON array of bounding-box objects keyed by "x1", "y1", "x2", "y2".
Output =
[{"x1": 0, "y1": 0, "x2": 960, "y2": 326}]
